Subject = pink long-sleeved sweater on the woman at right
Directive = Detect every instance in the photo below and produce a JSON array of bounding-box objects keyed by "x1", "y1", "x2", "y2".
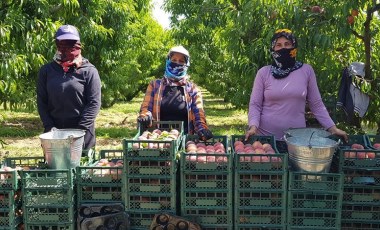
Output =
[{"x1": 248, "y1": 64, "x2": 335, "y2": 140}]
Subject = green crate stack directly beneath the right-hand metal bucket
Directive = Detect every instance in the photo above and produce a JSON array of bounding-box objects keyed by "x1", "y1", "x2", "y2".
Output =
[{"x1": 287, "y1": 172, "x2": 343, "y2": 230}]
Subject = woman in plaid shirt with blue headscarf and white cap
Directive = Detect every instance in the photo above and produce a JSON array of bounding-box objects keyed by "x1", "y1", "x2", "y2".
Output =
[{"x1": 137, "y1": 46, "x2": 213, "y2": 140}]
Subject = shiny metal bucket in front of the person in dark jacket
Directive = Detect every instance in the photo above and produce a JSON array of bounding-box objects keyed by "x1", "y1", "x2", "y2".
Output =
[{"x1": 39, "y1": 129, "x2": 86, "y2": 169}]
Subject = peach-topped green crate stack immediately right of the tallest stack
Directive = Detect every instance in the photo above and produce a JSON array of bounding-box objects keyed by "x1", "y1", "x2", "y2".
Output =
[{"x1": 180, "y1": 135, "x2": 233, "y2": 230}]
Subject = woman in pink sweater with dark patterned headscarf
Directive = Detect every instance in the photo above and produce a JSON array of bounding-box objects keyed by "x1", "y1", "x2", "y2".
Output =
[{"x1": 245, "y1": 29, "x2": 348, "y2": 151}]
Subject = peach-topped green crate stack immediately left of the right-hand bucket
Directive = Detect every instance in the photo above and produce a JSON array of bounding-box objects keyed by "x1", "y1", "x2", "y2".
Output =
[{"x1": 231, "y1": 136, "x2": 288, "y2": 230}]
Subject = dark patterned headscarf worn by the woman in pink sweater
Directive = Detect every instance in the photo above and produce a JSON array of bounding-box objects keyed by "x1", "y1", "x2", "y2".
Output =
[{"x1": 270, "y1": 29, "x2": 303, "y2": 79}]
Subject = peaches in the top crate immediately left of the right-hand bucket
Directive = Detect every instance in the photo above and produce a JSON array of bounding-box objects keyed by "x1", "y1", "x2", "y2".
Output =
[{"x1": 234, "y1": 141, "x2": 281, "y2": 162}]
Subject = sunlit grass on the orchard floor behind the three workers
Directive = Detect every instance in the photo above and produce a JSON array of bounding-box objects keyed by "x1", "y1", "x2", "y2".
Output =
[{"x1": 0, "y1": 91, "x2": 247, "y2": 157}]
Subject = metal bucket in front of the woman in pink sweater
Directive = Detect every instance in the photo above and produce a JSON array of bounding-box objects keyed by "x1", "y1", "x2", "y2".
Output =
[{"x1": 284, "y1": 130, "x2": 339, "y2": 172}]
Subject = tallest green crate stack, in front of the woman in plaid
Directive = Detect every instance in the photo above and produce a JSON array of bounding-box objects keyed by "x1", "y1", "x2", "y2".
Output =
[{"x1": 123, "y1": 121, "x2": 183, "y2": 230}]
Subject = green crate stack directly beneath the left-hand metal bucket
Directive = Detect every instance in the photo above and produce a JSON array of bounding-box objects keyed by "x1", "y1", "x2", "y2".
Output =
[{"x1": 21, "y1": 169, "x2": 76, "y2": 230}]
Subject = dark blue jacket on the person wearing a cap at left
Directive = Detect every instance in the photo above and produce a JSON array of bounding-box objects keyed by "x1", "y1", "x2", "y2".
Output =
[{"x1": 37, "y1": 59, "x2": 101, "y2": 148}]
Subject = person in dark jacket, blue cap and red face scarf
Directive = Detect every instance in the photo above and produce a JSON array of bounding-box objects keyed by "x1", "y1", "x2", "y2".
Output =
[{"x1": 37, "y1": 25, "x2": 101, "y2": 153}]
